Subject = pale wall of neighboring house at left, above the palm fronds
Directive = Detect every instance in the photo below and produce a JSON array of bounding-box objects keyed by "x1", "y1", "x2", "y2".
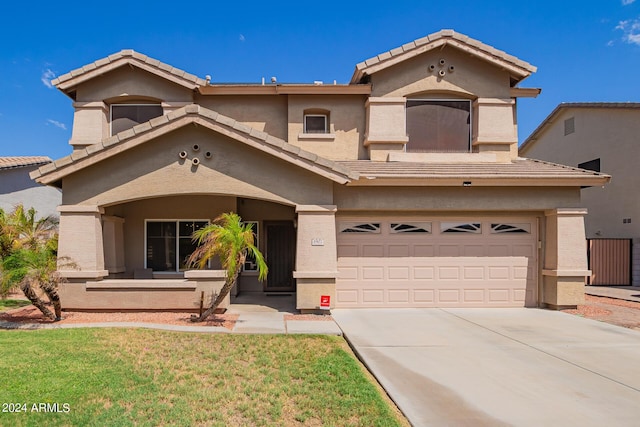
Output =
[{"x1": 0, "y1": 166, "x2": 62, "y2": 218}]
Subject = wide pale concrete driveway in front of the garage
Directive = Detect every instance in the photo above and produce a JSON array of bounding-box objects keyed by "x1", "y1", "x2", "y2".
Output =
[{"x1": 332, "y1": 309, "x2": 640, "y2": 426}]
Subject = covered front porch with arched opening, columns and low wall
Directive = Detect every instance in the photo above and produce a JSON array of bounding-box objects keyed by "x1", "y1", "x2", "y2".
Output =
[{"x1": 60, "y1": 195, "x2": 337, "y2": 312}]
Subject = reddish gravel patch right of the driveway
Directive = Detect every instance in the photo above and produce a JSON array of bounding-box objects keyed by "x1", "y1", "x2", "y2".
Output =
[{"x1": 563, "y1": 295, "x2": 640, "y2": 330}]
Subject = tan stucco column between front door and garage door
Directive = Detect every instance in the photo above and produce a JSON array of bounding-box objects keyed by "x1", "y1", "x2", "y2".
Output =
[{"x1": 293, "y1": 205, "x2": 338, "y2": 311}]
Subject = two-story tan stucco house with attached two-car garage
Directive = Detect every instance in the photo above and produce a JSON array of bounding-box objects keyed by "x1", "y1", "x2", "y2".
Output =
[{"x1": 32, "y1": 30, "x2": 609, "y2": 311}]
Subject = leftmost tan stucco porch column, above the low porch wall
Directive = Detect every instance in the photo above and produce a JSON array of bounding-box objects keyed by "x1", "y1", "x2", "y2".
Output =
[{"x1": 58, "y1": 205, "x2": 109, "y2": 280}]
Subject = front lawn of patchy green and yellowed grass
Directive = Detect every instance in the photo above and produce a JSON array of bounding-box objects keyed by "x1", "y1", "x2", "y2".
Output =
[{"x1": 0, "y1": 329, "x2": 408, "y2": 426}]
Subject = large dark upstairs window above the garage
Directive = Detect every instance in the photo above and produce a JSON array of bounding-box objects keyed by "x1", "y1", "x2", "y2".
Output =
[{"x1": 406, "y1": 99, "x2": 471, "y2": 153}]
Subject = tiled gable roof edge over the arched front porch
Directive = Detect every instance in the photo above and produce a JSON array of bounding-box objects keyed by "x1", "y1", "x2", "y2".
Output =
[{"x1": 30, "y1": 104, "x2": 358, "y2": 184}]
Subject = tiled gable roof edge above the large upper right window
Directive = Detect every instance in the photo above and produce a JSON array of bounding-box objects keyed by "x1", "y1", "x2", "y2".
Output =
[{"x1": 351, "y1": 30, "x2": 537, "y2": 84}]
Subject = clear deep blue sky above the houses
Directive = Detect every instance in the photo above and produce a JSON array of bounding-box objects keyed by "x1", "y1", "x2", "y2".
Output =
[{"x1": 0, "y1": 0, "x2": 640, "y2": 158}]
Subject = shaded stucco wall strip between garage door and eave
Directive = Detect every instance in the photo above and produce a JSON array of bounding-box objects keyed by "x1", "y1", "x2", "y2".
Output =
[{"x1": 334, "y1": 185, "x2": 580, "y2": 212}]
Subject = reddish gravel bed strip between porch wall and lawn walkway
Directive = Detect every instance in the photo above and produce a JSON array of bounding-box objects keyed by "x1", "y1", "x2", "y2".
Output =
[{"x1": 0, "y1": 305, "x2": 238, "y2": 330}]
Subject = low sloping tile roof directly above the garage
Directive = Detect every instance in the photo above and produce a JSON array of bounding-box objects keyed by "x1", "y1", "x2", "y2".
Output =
[{"x1": 339, "y1": 158, "x2": 610, "y2": 185}]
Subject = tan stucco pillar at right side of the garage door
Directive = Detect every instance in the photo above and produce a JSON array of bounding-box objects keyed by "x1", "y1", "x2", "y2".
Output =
[{"x1": 542, "y1": 208, "x2": 591, "y2": 308}]
